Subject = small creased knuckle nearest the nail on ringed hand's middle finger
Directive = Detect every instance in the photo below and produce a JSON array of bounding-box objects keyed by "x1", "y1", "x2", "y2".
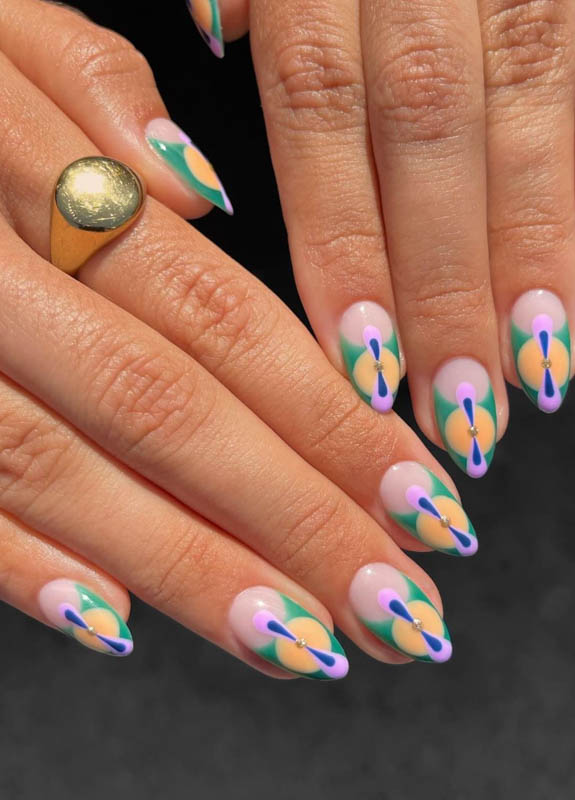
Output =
[{"x1": 273, "y1": 493, "x2": 349, "y2": 579}]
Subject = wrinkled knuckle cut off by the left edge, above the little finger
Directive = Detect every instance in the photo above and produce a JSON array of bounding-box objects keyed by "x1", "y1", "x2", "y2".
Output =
[{"x1": 0, "y1": 404, "x2": 74, "y2": 509}]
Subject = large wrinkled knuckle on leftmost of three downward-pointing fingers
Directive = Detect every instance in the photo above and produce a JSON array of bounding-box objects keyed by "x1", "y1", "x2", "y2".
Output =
[{"x1": 265, "y1": 24, "x2": 365, "y2": 130}]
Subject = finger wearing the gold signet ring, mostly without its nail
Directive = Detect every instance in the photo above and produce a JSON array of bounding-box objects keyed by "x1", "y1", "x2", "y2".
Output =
[{"x1": 0, "y1": 47, "x2": 476, "y2": 554}]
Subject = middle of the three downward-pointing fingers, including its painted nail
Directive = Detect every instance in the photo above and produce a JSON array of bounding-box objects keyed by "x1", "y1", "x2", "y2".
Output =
[{"x1": 362, "y1": 0, "x2": 507, "y2": 477}]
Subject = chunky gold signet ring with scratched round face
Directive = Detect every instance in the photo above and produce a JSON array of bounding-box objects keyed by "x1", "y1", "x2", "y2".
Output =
[{"x1": 50, "y1": 156, "x2": 146, "y2": 274}]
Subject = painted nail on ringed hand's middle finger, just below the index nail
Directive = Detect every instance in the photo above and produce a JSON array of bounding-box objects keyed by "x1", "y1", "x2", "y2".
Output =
[{"x1": 350, "y1": 564, "x2": 452, "y2": 663}]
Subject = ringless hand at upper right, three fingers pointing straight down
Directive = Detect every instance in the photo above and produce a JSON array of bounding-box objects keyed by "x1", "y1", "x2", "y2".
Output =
[{"x1": 212, "y1": 0, "x2": 575, "y2": 477}]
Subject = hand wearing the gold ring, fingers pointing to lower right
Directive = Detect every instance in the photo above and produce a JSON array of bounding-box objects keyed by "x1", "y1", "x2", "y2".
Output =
[{"x1": 0, "y1": 0, "x2": 476, "y2": 678}]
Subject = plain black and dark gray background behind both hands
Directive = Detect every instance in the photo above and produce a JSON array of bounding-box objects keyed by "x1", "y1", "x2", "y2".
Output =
[{"x1": 0, "y1": 0, "x2": 575, "y2": 800}]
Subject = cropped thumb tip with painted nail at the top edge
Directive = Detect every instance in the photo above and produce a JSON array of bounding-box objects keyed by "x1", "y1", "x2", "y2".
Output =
[{"x1": 186, "y1": 0, "x2": 248, "y2": 58}]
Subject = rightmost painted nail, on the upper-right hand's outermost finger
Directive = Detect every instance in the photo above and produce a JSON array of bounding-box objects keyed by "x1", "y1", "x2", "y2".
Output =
[{"x1": 511, "y1": 289, "x2": 571, "y2": 414}]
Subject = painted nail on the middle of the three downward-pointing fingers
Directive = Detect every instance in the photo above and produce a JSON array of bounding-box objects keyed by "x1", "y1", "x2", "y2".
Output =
[{"x1": 433, "y1": 358, "x2": 497, "y2": 478}]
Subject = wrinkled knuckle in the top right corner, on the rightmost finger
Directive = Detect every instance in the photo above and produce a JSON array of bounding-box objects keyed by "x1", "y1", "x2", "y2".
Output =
[{"x1": 483, "y1": 0, "x2": 573, "y2": 91}]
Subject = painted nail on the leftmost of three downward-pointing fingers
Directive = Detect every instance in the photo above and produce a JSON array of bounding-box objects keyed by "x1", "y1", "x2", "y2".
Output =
[{"x1": 339, "y1": 300, "x2": 401, "y2": 412}]
